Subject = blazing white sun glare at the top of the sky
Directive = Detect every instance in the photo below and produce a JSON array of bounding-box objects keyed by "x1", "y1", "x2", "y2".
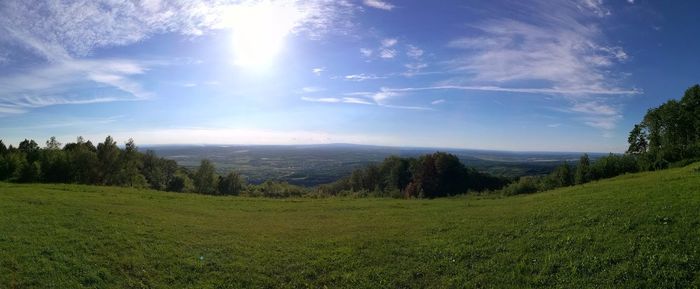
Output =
[{"x1": 227, "y1": 1, "x2": 304, "y2": 69}]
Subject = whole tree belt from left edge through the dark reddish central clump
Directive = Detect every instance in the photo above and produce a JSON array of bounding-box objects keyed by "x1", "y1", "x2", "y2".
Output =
[{"x1": 0, "y1": 136, "x2": 508, "y2": 198}]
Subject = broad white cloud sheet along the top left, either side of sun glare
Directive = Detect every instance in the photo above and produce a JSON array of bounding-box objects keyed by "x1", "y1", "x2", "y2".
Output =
[{"x1": 0, "y1": 0, "x2": 356, "y2": 61}]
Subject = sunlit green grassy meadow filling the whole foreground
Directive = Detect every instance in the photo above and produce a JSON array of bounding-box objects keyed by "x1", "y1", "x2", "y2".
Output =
[{"x1": 0, "y1": 164, "x2": 700, "y2": 289}]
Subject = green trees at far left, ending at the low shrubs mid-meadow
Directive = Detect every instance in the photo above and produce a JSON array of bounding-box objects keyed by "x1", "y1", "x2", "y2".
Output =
[{"x1": 0, "y1": 136, "x2": 249, "y2": 195}]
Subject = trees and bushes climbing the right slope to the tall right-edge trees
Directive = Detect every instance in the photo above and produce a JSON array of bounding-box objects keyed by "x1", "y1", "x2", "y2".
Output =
[{"x1": 501, "y1": 85, "x2": 700, "y2": 195}]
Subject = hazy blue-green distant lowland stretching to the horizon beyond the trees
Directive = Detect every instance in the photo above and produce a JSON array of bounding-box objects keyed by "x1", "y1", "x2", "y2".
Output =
[{"x1": 147, "y1": 144, "x2": 601, "y2": 186}]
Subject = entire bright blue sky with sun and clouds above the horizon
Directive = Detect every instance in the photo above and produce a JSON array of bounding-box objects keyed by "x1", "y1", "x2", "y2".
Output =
[{"x1": 0, "y1": 0, "x2": 700, "y2": 152}]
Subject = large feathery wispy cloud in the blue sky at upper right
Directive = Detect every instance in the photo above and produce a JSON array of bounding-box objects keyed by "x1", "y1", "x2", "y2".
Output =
[{"x1": 448, "y1": 0, "x2": 641, "y2": 130}]
